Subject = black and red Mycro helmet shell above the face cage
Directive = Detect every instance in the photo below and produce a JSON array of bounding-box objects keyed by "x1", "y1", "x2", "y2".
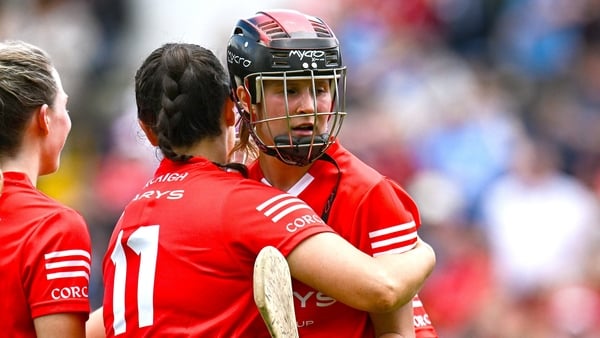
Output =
[{"x1": 227, "y1": 10, "x2": 343, "y2": 103}]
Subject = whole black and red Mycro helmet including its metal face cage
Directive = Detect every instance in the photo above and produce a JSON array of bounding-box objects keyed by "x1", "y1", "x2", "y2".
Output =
[{"x1": 227, "y1": 10, "x2": 346, "y2": 166}]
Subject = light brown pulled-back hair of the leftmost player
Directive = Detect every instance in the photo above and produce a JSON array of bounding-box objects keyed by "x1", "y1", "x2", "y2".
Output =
[{"x1": 0, "y1": 41, "x2": 58, "y2": 158}]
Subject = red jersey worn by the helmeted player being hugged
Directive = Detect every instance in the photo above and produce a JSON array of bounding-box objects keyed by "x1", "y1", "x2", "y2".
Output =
[{"x1": 249, "y1": 143, "x2": 437, "y2": 338}]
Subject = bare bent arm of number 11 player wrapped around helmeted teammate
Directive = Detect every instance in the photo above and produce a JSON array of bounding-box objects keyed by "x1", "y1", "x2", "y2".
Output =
[{"x1": 287, "y1": 233, "x2": 435, "y2": 313}]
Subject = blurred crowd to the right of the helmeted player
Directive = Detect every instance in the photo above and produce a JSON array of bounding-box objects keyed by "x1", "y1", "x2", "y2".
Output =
[{"x1": 307, "y1": 0, "x2": 600, "y2": 338}]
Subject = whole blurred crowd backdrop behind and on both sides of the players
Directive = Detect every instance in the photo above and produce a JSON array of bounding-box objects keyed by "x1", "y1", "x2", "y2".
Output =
[{"x1": 0, "y1": 0, "x2": 600, "y2": 338}]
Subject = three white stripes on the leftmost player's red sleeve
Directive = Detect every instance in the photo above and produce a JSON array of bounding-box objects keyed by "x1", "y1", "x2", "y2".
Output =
[{"x1": 44, "y1": 250, "x2": 91, "y2": 280}]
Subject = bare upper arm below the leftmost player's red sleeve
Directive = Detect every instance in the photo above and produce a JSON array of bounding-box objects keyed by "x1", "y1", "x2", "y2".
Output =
[{"x1": 33, "y1": 313, "x2": 86, "y2": 338}]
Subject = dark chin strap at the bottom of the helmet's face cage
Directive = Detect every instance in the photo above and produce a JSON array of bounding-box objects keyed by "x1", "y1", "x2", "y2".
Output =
[{"x1": 265, "y1": 133, "x2": 329, "y2": 167}]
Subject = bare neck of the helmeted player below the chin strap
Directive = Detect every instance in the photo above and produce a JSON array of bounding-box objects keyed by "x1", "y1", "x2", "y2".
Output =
[{"x1": 258, "y1": 153, "x2": 311, "y2": 191}]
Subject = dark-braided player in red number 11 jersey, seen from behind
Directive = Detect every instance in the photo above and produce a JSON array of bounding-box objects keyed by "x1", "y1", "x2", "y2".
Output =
[{"x1": 88, "y1": 43, "x2": 435, "y2": 337}]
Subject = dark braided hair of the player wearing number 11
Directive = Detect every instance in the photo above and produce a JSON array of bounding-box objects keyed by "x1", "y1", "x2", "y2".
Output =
[{"x1": 135, "y1": 43, "x2": 229, "y2": 161}]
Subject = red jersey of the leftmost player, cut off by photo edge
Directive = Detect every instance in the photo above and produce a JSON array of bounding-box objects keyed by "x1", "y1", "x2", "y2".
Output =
[{"x1": 0, "y1": 172, "x2": 91, "y2": 337}]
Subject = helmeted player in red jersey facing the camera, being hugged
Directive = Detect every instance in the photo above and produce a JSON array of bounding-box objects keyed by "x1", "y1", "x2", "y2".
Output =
[{"x1": 227, "y1": 10, "x2": 437, "y2": 338}]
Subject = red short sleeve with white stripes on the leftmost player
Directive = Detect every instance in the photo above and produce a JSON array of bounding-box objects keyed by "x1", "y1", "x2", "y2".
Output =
[{"x1": 21, "y1": 209, "x2": 91, "y2": 318}]
